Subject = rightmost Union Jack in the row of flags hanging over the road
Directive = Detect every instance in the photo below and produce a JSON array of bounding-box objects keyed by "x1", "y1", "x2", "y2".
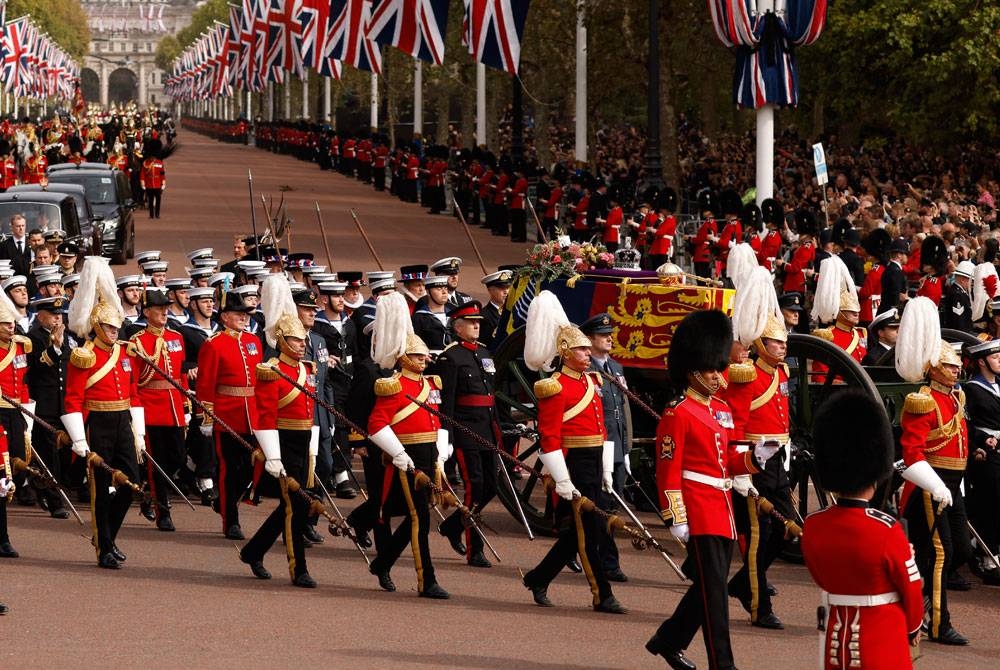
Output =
[{"x1": 462, "y1": 0, "x2": 531, "y2": 74}]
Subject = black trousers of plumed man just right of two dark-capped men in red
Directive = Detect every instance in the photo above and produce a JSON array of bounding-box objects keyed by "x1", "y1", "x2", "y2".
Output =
[{"x1": 240, "y1": 429, "x2": 311, "y2": 580}]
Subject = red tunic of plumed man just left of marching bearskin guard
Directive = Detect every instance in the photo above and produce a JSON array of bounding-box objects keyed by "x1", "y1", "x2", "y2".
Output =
[{"x1": 535, "y1": 367, "x2": 607, "y2": 456}]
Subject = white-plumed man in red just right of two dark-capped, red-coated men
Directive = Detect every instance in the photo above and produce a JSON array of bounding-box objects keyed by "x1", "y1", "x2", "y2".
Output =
[{"x1": 240, "y1": 275, "x2": 319, "y2": 589}]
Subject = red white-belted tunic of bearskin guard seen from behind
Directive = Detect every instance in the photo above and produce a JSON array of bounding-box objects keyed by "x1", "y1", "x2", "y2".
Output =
[{"x1": 801, "y1": 499, "x2": 924, "y2": 670}]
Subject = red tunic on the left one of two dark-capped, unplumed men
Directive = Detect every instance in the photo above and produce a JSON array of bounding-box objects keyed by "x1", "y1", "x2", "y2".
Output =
[{"x1": 131, "y1": 327, "x2": 187, "y2": 426}]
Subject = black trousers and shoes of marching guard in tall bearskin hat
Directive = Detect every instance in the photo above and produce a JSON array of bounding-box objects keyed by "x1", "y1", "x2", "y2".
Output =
[{"x1": 656, "y1": 535, "x2": 735, "y2": 670}]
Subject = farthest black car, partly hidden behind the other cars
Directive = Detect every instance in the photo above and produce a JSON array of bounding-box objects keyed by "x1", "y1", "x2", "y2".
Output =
[{"x1": 45, "y1": 163, "x2": 136, "y2": 264}]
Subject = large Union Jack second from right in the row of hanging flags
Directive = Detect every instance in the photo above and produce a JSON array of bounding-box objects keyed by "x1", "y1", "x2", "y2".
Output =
[{"x1": 368, "y1": 0, "x2": 448, "y2": 65}]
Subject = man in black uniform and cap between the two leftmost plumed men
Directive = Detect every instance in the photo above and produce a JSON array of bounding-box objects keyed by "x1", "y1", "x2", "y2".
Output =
[{"x1": 25, "y1": 297, "x2": 76, "y2": 519}]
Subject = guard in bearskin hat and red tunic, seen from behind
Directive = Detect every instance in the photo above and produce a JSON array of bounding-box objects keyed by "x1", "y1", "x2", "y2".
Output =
[{"x1": 802, "y1": 390, "x2": 924, "y2": 670}]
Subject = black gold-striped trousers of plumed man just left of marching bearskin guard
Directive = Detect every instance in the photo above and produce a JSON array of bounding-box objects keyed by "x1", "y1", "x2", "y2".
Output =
[{"x1": 524, "y1": 447, "x2": 612, "y2": 605}]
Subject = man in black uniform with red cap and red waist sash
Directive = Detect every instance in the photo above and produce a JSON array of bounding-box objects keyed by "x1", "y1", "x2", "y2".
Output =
[{"x1": 432, "y1": 300, "x2": 501, "y2": 568}]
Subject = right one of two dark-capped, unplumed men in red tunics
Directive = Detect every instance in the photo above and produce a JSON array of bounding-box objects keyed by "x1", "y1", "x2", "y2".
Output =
[{"x1": 197, "y1": 292, "x2": 263, "y2": 540}]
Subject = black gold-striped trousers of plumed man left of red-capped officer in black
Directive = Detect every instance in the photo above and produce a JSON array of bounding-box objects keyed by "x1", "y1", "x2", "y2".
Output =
[{"x1": 371, "y1": 443, "x2": 437, "y2": 593}]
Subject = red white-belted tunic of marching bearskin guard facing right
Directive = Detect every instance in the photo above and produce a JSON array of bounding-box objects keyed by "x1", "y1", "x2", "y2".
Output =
[{"x1": 656, "y1": 389, "x2": 758, "y2": 540}]
